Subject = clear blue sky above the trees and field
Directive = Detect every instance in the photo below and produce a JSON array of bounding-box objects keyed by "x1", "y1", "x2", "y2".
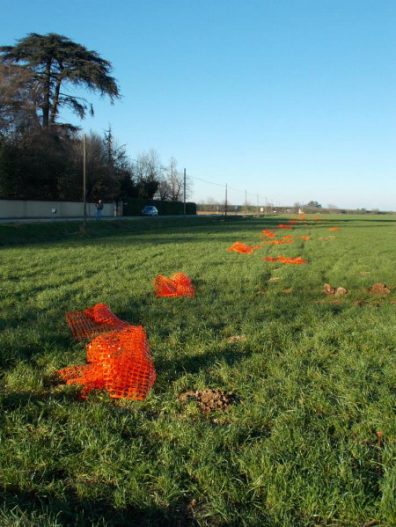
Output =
[{"x1": 0, "y1": 0, "x2": 396, "y2": 210}]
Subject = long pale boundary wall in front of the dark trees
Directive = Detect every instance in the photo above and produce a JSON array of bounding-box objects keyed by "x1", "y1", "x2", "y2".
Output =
[{"x1": 0, "y1": 199, "x2": 122, "y2": 219}]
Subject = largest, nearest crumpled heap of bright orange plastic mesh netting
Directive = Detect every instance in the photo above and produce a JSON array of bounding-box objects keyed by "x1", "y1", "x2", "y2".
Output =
[{"x1": 57, "y1": 325, "x2": 156, "y2": 400}]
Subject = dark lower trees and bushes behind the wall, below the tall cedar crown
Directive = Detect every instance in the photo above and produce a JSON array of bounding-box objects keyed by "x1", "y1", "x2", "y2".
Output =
[{"x1": 0, "y1": 127, "x2": 195, "y2": 208}]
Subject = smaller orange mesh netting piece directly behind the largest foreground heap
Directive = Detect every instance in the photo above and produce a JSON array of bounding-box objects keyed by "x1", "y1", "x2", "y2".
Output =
[{"x1": 66, "y1": 304, "x2": 128, "y2": 340}]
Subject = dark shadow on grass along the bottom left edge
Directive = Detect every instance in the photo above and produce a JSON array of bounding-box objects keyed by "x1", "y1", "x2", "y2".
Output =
[{"x1": 0, "y1": 488, "x2": 197, "y2": 527}]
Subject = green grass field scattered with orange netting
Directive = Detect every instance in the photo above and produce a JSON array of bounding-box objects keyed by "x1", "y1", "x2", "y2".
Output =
[{"x1": 0, "y1": 215, "x2": 396, "y2": 527}]
